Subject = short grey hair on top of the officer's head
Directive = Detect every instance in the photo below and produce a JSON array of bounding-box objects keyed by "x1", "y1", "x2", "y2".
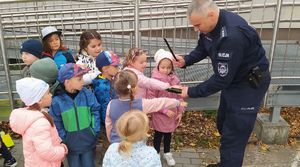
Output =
[{"x1": 187, "y1": 0, "x2": 218, "y2": 17}]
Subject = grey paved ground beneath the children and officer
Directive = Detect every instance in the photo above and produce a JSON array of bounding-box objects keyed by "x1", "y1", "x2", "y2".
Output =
[{"x1": 0, "y1": 140, "x2": 300, "y2": 167}]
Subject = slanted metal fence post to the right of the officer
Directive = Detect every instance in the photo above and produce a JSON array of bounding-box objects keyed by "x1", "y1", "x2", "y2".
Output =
[{"x1": 264, "y1": 0, "x2": 282, "y2": 123}]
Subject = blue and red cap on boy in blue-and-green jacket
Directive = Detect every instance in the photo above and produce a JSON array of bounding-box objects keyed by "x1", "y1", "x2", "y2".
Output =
[{"x1": 57, "y1": 63, "x2": 90, "y2": 83}]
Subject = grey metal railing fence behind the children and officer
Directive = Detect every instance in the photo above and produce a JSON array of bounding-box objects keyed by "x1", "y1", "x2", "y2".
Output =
[{"x1": 0, "y1": 0, "x2": 300, "y2": 120}]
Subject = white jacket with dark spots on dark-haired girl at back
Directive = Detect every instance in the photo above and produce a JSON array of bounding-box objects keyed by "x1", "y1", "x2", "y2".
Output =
[{"x1": 76, "y1": 51, "x2": 100, "y2": 85}]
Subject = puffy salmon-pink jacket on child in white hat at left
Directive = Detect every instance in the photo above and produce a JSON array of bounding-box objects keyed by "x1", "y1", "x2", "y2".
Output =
[{"x1": 9, "y1": 108, "x2": 67, "y2": 167}]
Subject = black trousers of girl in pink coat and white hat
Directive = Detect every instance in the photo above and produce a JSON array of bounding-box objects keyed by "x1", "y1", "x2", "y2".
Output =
[{"x1": 153, "y1": 130, "x2": 172, "y2": 153}]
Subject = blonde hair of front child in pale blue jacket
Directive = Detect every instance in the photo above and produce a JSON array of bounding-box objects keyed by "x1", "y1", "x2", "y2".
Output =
[{"x1": 116, "y1": 110, "x2": 149, "y2": 154}]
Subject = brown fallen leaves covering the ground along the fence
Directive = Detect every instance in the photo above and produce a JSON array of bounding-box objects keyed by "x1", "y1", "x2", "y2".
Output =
[{"x1": 0, "y1": 107, "x2": 300, "y2": 151}]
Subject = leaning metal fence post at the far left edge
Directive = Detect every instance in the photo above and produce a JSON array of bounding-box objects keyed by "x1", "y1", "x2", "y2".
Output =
[{"x1": 0, "y1": 16, "x2": 15, "y2": 110}]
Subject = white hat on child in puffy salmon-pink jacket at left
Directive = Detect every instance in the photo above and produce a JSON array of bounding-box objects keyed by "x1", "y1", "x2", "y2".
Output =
[{"x1": 16, "y1": 77, "x2": 49, "y2": 106}]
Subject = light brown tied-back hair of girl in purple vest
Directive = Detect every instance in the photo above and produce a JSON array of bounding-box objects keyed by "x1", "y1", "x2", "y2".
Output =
[{"x1": 113, "y1": 70, "x2": 138, "y2": 109}]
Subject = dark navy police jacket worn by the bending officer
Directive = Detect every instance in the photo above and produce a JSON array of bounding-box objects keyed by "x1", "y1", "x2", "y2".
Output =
[{"x1": 184, "y1": 10, "x2": 269, "y2": 97}]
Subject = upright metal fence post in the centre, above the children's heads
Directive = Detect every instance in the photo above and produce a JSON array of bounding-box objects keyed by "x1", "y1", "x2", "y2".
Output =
[{"x1": 134, "y1": 0, "x2": 141, "y2": 48}]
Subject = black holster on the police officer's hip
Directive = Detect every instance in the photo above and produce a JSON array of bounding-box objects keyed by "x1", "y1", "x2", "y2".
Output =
[{"x1": 247, "y1": 66, "x2": 263, "y2": 88}]
